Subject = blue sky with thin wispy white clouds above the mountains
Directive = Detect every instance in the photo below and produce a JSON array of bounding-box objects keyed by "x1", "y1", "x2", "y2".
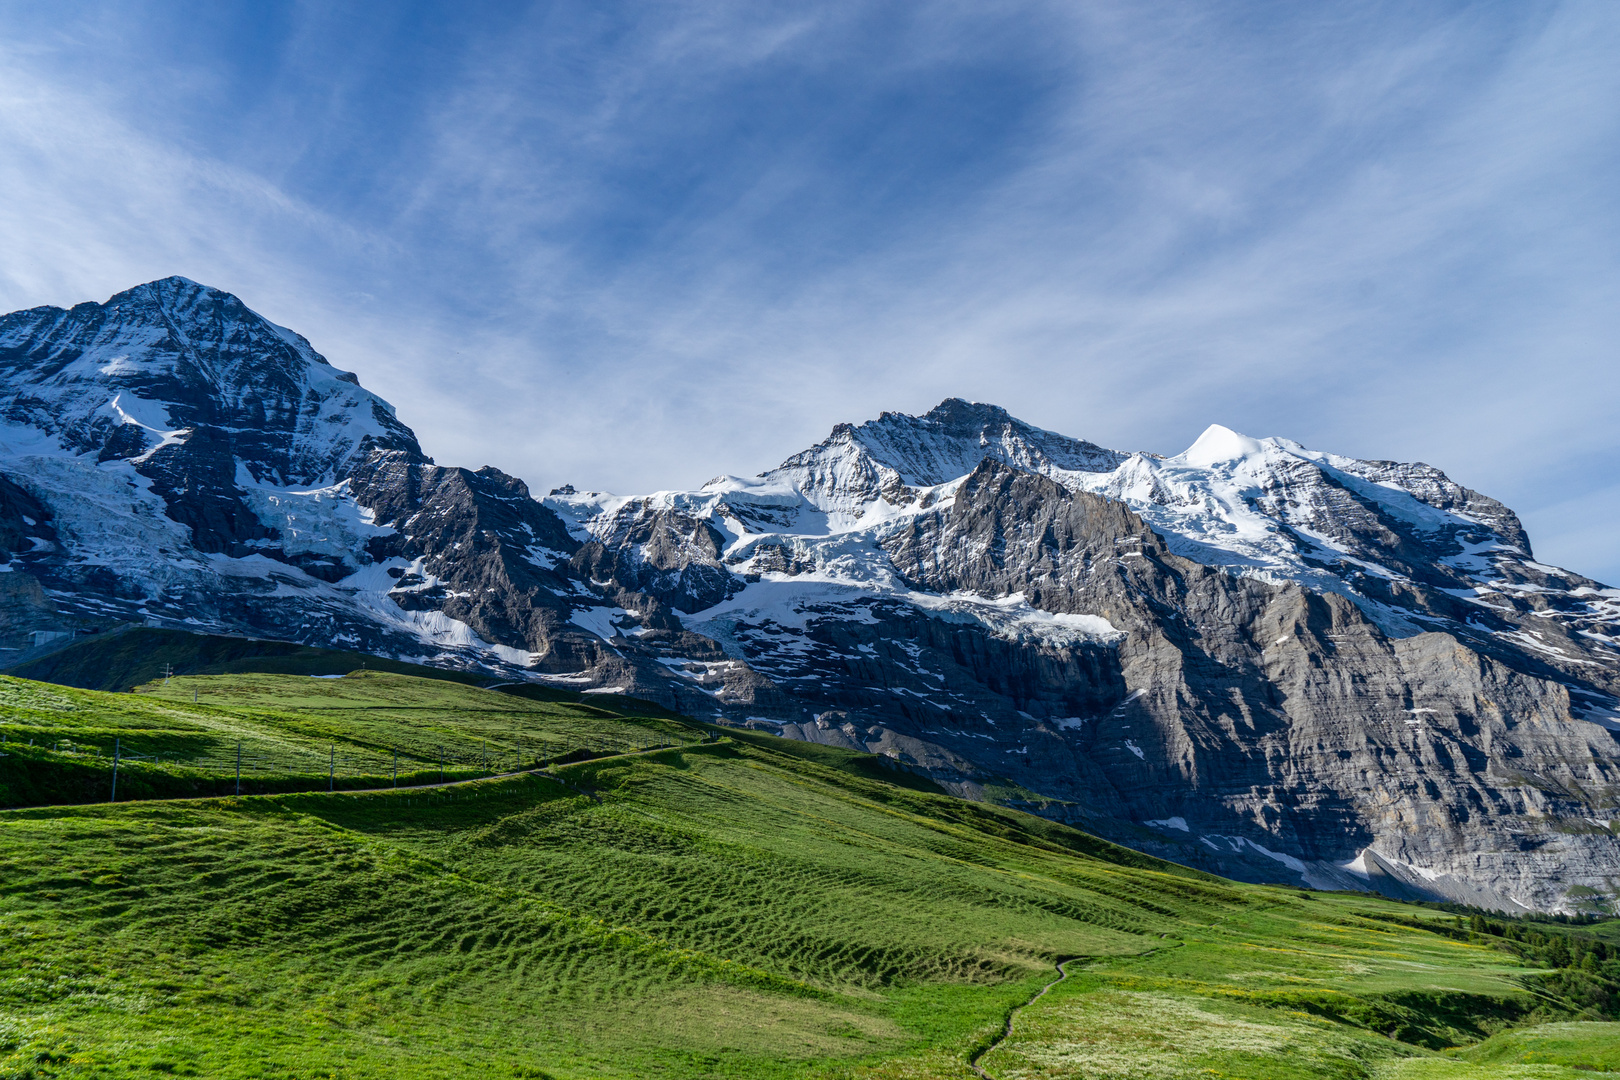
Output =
[{"x1": 0, "y1": 0, "x2": 1620, "y2": 581}]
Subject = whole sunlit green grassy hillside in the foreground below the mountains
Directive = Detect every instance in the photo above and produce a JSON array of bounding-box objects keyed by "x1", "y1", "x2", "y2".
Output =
[{"x1": 0, "y1": 674, "x2": 1620, "y2": 1080}]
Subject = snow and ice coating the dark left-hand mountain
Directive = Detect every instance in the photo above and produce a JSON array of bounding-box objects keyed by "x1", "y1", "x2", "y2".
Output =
[{"x1": 0, "y1": 279, "x2": 492, "y2": 664}]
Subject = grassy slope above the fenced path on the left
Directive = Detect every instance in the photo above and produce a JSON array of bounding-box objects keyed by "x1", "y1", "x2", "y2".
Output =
[{"x1": 0, "y1": 670, "x2": 697, "y2": 806}]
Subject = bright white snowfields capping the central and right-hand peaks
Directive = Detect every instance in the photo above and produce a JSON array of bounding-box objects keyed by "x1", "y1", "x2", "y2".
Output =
[{"x1": 544, "y1": 400, "x2": 1620, "y2": 665}]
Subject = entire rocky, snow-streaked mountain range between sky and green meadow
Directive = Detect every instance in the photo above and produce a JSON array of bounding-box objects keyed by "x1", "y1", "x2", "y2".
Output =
[{"x1": 0, "y1": 279, "x2": 1620, "y2": 910}]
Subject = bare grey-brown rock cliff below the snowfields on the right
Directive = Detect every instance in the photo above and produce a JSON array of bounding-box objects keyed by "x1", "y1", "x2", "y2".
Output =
[{"x1": 885, "y1": 461, "x2": 1620, "y2": 907}]
